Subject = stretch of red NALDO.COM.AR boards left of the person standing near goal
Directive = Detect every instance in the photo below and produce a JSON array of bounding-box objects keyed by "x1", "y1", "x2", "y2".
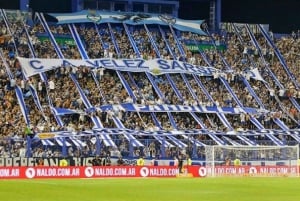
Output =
[{"x1": 0, "y1": 166, "x2": 178, "y2": 179}]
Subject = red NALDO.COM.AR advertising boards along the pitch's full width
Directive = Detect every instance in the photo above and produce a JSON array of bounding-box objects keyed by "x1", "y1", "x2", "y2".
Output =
[{"x1": 0, "y1": 166, "x2": 299, "y2": 179}]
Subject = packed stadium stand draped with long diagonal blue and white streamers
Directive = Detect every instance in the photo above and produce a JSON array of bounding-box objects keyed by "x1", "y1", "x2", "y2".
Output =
[{"x1": 0, "y1": 9, "x2": 300, "y2": 163}]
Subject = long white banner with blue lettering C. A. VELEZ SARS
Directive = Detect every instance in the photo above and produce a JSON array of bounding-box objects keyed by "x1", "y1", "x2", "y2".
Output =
[{"x1": 18, "y1": 57, "x2": 220, "y2": 77}]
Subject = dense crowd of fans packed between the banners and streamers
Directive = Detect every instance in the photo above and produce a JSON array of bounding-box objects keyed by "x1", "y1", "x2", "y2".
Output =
[{"x1": 0, "y1": 10, "x2": 300, "y2": 158}]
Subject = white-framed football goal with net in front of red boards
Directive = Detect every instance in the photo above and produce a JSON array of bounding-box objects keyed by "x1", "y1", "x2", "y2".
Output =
[{"x1": 205, "y1": 145, "x2": 299, "y2": 176}]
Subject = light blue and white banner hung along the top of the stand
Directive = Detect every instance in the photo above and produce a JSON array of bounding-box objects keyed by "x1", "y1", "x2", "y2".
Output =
[{"x1": 49, "y1": 10, "x2": 206, "y2": 35}]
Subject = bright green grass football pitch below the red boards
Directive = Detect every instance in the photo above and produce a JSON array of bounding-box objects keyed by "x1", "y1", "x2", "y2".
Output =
[{"x1": 0, "y1": 177, "x2": 300, "y2": 201}]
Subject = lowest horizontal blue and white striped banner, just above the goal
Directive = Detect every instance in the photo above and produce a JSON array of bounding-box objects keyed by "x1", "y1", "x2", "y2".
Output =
[{"x1": 32, "y1": 128, "x2": 300, "y2": 147}]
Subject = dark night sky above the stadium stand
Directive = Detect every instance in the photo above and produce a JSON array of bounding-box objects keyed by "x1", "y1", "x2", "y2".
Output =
[{"x1": 0, "y1": 0, "x2": 300, "y2": 33}]
